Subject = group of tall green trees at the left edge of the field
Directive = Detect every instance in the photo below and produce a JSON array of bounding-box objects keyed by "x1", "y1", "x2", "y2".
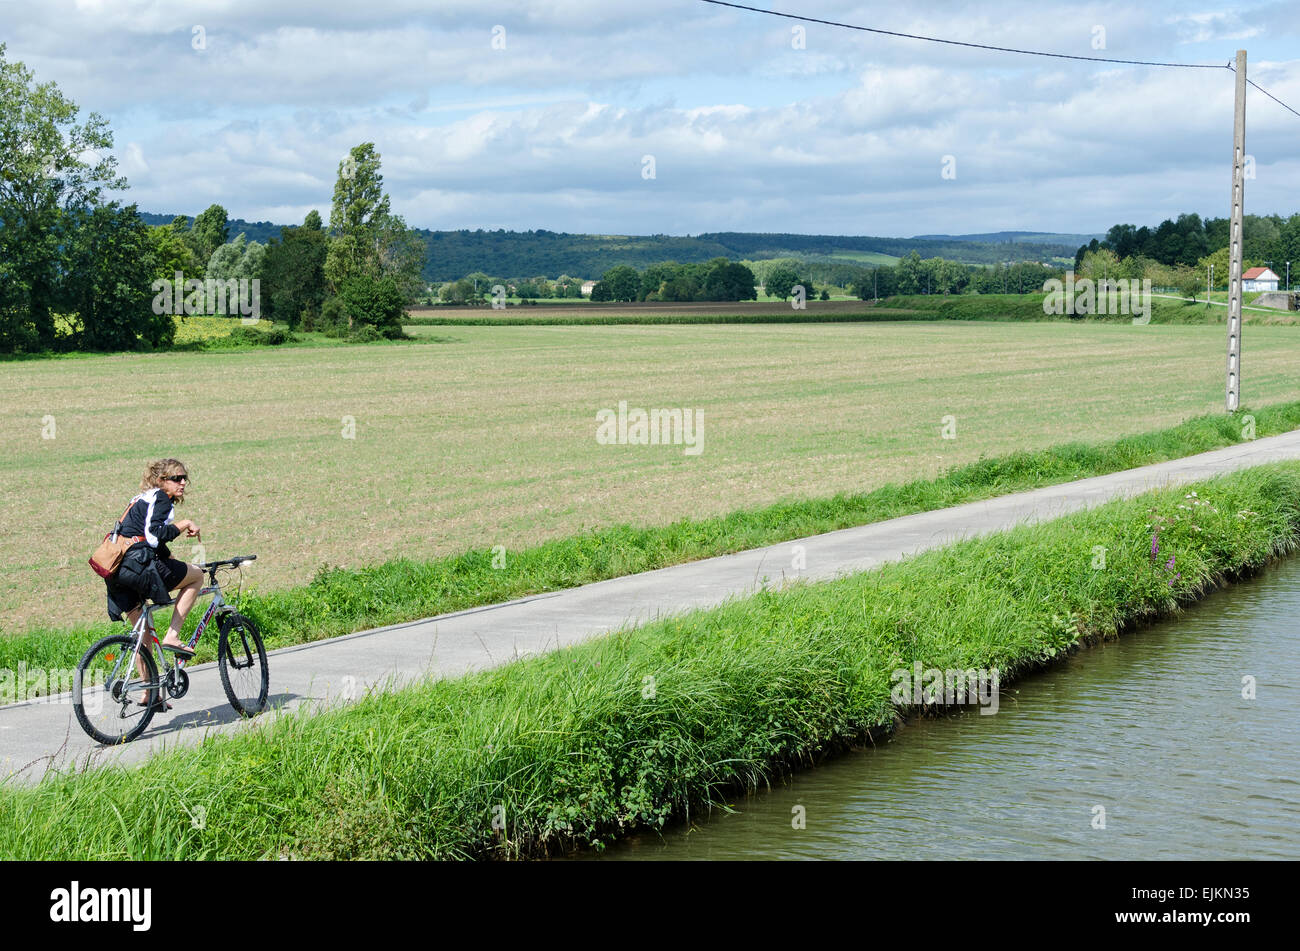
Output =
[{"x1": 0, "y1": 44, "x2": 425, "y2": 353}]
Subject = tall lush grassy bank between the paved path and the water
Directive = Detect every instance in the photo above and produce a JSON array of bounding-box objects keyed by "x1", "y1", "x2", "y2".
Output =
[{"x1": 0, "y1": 463, "x2": 1300, "y2": 859}]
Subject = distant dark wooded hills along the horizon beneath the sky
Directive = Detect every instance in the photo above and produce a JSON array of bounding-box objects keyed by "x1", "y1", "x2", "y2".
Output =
[{"x1": 140, "y1": 212, "x2": 1093, "y2": 282}]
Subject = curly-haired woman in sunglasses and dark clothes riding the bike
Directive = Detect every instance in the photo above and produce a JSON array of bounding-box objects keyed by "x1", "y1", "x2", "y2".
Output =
[{"x1": 104, "y1": 459, "x2": 203, "y2": 659}]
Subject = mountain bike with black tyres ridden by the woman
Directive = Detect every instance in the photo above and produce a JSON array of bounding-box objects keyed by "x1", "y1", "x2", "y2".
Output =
[{"x1": 73, "y1": 555, "x2": 270, "y2": 746}]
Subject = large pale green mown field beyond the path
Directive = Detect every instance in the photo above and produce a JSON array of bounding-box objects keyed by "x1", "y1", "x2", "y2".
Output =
[{"x1": 0, "y1": 322, "x2": 1300, "y2": 631}]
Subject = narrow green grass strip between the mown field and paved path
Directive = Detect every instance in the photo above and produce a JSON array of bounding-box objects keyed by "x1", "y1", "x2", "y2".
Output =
[{"x1": 0, "y1": 403, "x2": 1300, "y2": 702}]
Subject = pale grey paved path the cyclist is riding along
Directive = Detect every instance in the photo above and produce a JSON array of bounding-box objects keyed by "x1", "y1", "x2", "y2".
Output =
[{"x1": 0, "y1": 430, "x2": 1300, "y2": 781}]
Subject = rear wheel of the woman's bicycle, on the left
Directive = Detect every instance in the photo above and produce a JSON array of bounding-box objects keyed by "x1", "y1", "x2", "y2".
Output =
[{"x1": 73, "y1": 634, "x2": 160, "y2": 746}]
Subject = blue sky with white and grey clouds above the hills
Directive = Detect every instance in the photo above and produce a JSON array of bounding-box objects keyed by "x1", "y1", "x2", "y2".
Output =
[{"x1": 0, "y1": 0, "x2": 1300, "y2": 236}]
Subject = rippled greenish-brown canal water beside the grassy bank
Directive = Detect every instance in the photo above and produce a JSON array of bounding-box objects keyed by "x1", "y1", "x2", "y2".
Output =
[{"x1": 585, "y1": 557, "x2": 1300, "y2": 860}]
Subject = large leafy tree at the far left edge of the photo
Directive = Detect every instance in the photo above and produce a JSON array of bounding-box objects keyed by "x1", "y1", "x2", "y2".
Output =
[{"x1": 0, "y1": 43, "x2": 126, "y2": 351}]
